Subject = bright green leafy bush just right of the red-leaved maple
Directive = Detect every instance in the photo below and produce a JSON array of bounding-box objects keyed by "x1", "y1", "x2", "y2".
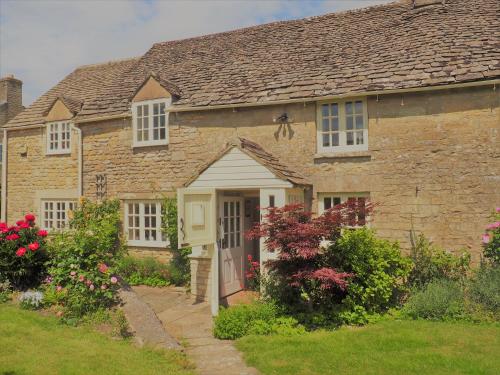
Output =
[{"x1": 325, "y1": 228, "x2": 411, "y2": 324}]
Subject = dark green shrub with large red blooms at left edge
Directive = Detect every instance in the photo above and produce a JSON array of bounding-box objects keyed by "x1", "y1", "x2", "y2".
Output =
[{"x1": 0, "y1": 214, "x2": 48, "y2": 289}]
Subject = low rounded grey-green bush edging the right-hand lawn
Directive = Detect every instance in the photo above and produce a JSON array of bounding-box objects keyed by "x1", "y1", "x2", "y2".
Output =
[{"x1": 403, "y1": 279, "x2": 467, "y2": 320}]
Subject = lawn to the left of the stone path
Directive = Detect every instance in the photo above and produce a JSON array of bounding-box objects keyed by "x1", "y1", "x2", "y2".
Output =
[{"x1": 0, "y1": 304, "x2": 192, "y2": 375}]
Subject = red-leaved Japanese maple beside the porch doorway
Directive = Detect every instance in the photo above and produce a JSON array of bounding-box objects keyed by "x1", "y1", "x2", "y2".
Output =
[{"x1": 247, "y1": 201, "x2": 372, "y2": 318}]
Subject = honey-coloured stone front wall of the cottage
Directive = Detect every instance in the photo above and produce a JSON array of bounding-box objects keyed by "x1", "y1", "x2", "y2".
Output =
[{"x1": 4, "y1": 87, "x2": 500, "y2": 260}]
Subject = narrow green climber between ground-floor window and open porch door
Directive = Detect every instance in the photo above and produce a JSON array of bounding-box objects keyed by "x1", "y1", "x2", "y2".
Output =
[{"x1": 162, "y1": 198, "x2": 191, "y2": 286}]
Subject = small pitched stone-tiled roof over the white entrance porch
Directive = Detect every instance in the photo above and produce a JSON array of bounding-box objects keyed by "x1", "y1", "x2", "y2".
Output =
[{"x1": 184, "y1": 137, "x2": 310, "y2": 186}]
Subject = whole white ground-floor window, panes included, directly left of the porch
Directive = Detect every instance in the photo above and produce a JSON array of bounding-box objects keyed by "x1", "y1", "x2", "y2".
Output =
[{"x1": 125, "y1": 201, "x2": 168, "y2": 247}]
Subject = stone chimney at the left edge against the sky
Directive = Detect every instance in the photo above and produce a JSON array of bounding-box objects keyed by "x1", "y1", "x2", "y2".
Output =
[{"x1": 0, "y1": 74, "x2": 24, "y2": 126}]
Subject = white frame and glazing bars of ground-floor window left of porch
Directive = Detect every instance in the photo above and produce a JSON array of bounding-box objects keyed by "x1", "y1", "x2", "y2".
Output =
[{"x1": 123, "y1": 200, "x2": 169, "y2": 248}]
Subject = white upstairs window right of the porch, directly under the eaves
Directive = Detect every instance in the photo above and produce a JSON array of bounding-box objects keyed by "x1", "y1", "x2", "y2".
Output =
[{"x1": 317, "y1": 99, "x2": 368, "y2": 152}]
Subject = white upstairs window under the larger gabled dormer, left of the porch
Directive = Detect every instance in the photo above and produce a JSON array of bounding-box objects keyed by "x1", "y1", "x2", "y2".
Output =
[{"x1": 132, "y1": 99, "x2": 171, "y2": 147}]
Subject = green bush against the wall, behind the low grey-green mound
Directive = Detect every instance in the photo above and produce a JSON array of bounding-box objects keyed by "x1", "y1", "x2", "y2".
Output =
[{"x1": 408, "y1": 232, "x2": 471, "y2": 288}]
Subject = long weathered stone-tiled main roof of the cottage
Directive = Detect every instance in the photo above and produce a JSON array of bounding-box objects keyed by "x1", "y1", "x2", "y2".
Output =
[{"x1": 3, "y1": 0, "x2": 500, "y2": 126}]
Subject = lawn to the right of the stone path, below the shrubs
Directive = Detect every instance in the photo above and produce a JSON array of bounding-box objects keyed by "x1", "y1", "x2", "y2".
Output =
[{"x1": 237, "y1": 320, "x2": 500, "y2": 375}]
